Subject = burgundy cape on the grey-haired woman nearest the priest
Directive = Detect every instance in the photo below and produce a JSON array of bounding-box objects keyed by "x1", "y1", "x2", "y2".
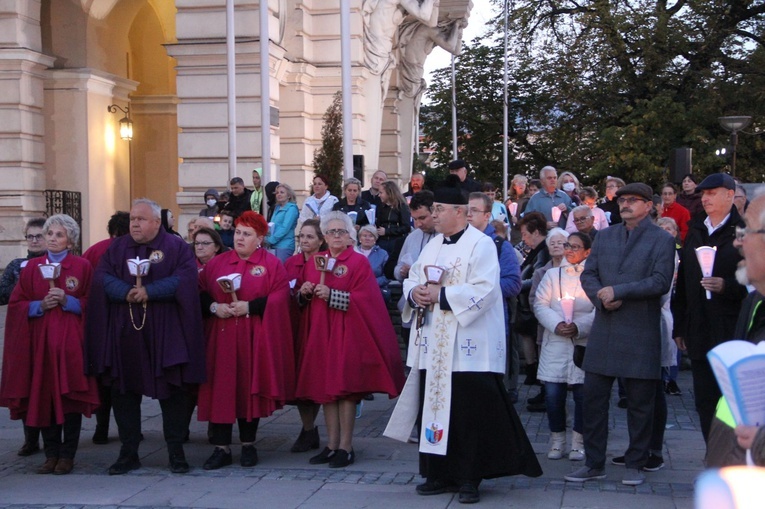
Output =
[{"x1": 295, "y1": 247, "x2": 404, "y2": 403}]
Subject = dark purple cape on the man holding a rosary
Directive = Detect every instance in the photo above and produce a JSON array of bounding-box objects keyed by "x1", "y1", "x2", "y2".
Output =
[{"x1": 85, "y1": 229, "x2": 205, "y2": 399}]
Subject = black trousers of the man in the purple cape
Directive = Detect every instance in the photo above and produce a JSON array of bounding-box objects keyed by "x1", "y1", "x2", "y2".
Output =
[{"x1": 112, "y1": 384, "x2": 188, "y2": 455}]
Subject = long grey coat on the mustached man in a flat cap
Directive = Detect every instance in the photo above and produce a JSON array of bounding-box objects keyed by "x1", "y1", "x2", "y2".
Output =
[{"x1": 581, "y1": 217, "x2": 675, "y2": 379}]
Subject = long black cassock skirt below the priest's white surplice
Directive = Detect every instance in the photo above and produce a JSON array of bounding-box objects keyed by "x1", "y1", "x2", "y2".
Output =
[{"x1": 418, "y1": 370, "x2": 542, "y2": 483}]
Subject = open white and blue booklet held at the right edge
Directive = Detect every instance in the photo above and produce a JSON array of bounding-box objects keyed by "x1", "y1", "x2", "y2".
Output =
[{"x1": 707, "y1": 339, "x2": 765, "y2": 426}]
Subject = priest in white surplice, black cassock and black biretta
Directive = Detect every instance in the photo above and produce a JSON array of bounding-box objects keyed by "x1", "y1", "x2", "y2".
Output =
[{"x1": 384, "y1": 177, "x2": 542, "y2": 503}]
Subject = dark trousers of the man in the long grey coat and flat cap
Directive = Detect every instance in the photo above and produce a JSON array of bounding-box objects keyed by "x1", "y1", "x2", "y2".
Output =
[{"x1": 583, "y1": 372, "x2": 661, "y2": 469}]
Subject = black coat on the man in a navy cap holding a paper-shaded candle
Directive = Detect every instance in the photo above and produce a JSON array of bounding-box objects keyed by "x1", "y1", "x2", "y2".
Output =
[{"x1": 673, "y1": 205, "x2": 747, "y2": 360}]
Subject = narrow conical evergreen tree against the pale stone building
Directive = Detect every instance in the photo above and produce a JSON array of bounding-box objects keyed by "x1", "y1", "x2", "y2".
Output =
[{"x1": 313, "y1": 92, "x2": 343, "y2": 196}]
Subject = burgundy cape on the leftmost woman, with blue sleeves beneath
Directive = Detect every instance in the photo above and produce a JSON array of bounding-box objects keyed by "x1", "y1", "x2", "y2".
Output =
[{"x1": 0, "y1": 255, "x2": 99, "y2": 428}]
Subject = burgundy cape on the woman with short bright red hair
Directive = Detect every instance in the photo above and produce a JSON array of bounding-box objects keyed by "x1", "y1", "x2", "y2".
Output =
[{"x1": 198, "y1": 249, "x2": 295, "y2": 424}]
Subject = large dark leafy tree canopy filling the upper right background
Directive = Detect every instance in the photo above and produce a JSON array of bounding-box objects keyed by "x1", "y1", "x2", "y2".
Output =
[{"x1": 422, "y1": 0, "x2": 765, "y2": 190}]
